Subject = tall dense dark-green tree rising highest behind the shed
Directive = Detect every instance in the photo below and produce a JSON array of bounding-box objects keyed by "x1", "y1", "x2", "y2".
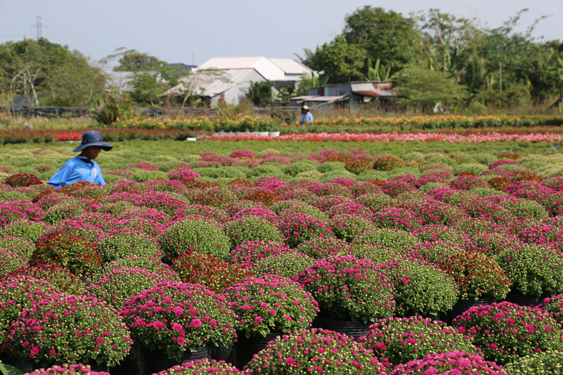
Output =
[{"x1": 342, "y1": 6, "x2": 422, "y2": 73}]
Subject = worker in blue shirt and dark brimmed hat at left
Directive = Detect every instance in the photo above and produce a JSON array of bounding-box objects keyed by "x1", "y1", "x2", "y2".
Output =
[{"x1": 47, "y1": 130, "x2": 113, "y2": 189}]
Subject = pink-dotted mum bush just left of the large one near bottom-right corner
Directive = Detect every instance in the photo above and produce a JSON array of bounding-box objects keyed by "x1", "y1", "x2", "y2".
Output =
[{"x1": 359, "y1": 316, "x2": 479, "y2": 366}]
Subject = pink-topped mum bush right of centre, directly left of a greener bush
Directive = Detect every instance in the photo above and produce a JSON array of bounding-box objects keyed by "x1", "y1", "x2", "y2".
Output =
[{"x1": 299, "y1": 255, "x2": 395, "y2": 323}]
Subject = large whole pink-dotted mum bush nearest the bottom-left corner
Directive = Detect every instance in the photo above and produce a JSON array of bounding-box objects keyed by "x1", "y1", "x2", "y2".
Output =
[{"x1": 2, "y1": 293, "x2": 132, "y2": 366}]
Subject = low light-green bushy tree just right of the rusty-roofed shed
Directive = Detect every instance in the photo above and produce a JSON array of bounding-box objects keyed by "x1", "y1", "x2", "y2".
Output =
[{"x1": 395, "y1": 66, "x2": 468, "y2": 110}]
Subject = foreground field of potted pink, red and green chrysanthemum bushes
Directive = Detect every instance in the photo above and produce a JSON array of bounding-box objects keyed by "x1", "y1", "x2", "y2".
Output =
[{"x1": 0, "y1": 148, "x2": 563, "y2": 375}]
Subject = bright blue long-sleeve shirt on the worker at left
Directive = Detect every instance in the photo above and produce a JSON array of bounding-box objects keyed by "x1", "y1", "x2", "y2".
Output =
[{"x1": 48, "y1": 156, "x2": 106, "y2": 189}]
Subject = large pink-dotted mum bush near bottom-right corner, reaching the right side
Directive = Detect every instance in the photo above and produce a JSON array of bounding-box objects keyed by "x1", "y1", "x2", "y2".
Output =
[{"x1": 453, "y1": 302, "x2": 563, "y2": 364}]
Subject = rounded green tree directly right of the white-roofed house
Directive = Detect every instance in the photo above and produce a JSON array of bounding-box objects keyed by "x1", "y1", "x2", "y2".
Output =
[{"x1": 309, "y1": 36, "x2": 367, "y2": 83}]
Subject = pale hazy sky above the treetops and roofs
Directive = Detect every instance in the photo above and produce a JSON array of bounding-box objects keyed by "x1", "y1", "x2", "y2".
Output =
[{"x1": 0, "y1": 0, "x2": 563, "y2": 65}]
